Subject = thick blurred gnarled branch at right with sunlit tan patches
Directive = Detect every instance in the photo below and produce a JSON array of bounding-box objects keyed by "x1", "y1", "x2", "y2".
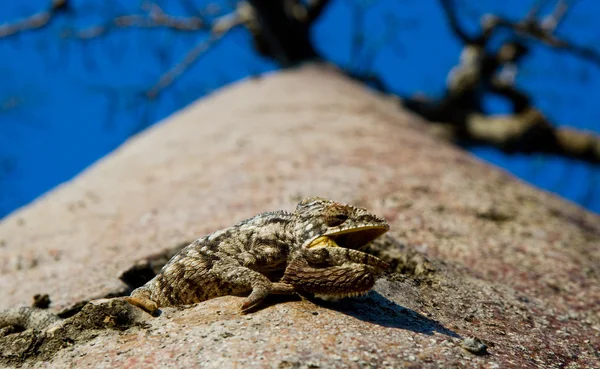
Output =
[{"x1": 403, "y1": 0, "x2": 600, "y2": 164}]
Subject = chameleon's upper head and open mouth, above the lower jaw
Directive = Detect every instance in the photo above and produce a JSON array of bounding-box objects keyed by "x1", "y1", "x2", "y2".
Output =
[{"x1": 294, "y1": 197, "x2": 390, "y2": 249}]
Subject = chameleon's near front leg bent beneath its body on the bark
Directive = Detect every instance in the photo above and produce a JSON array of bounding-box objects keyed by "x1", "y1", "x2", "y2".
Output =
[{"x1": 211, "y1": 262, "x2": 295, "y2": 312}]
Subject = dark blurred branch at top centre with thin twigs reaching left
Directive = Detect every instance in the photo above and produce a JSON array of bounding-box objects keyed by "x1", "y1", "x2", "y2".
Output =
[{"x1": 0, "y1": 0, "x2": 336, "y2": 98}]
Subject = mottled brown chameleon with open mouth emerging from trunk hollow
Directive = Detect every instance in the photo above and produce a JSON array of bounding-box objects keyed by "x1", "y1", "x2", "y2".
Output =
[{"x1": 126, "y1": 197, "x2": 389, "y2": 313}]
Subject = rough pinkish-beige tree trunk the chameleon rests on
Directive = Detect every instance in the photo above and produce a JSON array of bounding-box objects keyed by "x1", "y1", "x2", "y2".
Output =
[{"x1": 0, "y1": 66, "x2": 600, "y2": 368}]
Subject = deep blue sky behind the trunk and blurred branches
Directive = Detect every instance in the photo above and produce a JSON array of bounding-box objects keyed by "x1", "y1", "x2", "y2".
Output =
[{"x1": 0, "y1": 0, "x2": 600, "y2": 217}]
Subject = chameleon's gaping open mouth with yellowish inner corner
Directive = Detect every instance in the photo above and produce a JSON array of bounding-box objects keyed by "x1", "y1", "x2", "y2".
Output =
[{"x1": 306, "y1": 226, "x2": 389, "y2": 250}]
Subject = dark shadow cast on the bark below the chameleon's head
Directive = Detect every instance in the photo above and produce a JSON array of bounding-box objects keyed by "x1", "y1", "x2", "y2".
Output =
[{"x1": 312, "y1": 291, "x2": 461, "y2": 338}]
